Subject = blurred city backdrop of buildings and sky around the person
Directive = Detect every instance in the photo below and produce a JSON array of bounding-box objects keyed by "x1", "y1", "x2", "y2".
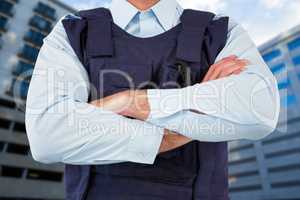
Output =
[{"x1": 0, "y1": 0, "x2": 300, "y2": 200}]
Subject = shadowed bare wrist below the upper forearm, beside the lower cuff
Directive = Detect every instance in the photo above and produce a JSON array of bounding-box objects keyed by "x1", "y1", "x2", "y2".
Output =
[{"x1": 159, "y1": 129, "x2": 192, "y2": 153}]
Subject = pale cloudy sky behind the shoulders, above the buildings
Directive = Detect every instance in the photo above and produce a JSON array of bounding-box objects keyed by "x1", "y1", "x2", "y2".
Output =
[{"x1": 63, "y1": 0, "x2": 300, "y2": 45}]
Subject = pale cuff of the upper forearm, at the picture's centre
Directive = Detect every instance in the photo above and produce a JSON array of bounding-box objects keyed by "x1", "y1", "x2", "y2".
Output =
[{"x1": 146, "y1": 88, "x2": 188, "y2": 122}]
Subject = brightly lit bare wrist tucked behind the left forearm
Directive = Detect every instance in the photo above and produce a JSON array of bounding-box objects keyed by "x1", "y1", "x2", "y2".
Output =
[{"x1": 91, "y1": 90, "x2": 150, "y2": 120}]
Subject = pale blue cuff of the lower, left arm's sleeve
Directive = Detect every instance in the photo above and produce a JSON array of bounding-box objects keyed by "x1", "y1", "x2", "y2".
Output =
[{"x1": 127, "y1": 123, "x2": 164, "y2": 164}]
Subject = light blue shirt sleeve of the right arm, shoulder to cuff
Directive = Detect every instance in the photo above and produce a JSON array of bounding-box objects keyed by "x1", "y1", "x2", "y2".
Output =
[{"x1": 146, "y1": 17, "x2": 280, "y2": 141}]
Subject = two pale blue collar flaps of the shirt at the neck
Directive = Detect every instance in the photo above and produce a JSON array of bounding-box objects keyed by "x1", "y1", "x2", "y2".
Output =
[{"x1": 110, "y1": 0, "x2": 180, "y2": 30}]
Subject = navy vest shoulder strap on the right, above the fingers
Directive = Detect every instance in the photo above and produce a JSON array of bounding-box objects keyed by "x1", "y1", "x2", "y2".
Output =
[{"x1": 176, "y1": 9, "x2": 228, "y2": 64}]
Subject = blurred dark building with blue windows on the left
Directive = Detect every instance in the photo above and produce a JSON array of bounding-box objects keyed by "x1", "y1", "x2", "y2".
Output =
[{"x1": 0, "y1": 0, "x2": 75, "y2": 200}]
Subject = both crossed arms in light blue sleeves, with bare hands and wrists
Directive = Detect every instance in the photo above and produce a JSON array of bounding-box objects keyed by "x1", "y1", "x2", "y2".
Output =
[{"x1": 25, "y1": 17, "x2": 279, "y2": 165}]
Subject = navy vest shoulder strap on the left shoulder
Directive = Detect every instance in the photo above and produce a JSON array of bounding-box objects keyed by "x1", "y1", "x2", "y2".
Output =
[{"x1": 62, "y1": 8, "x2": 113, "y2": 65}]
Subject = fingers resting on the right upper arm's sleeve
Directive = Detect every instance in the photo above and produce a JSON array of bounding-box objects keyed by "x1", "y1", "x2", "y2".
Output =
[{"x1": 202, "y1": 55, "x2": 250, "y2": 82}]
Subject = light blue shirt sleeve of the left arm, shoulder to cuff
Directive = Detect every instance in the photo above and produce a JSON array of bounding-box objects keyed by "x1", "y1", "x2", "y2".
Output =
[{"x1": 25, "y1": 16, "x2": 163, "y2": 165}]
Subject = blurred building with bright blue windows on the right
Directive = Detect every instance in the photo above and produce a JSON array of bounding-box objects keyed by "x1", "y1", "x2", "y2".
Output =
[{"x1": 229, "y1": 26, "x2": 300, "y2": 200}]
